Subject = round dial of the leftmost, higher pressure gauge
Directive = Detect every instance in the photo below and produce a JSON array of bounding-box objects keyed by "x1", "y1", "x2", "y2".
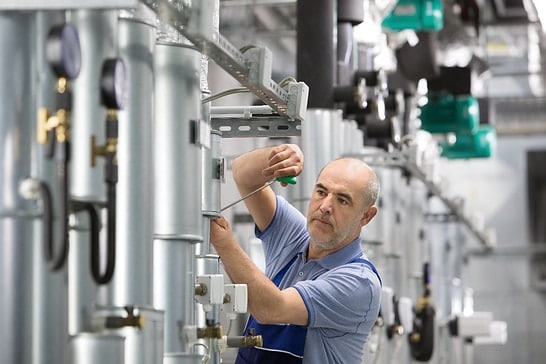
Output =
[{"x1": 46, "y1": 23, "x2": 82, "y2": 79}]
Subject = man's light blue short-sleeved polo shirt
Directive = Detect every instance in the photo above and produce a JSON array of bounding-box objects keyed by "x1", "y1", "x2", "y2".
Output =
[{"x1": 256, "y1": 196, "x2": 381, "y2": 364}]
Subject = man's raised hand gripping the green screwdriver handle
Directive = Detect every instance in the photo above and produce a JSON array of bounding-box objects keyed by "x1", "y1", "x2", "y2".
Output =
[{"x1": 262, "y1": 144, "x2": 303, "y2": 186}]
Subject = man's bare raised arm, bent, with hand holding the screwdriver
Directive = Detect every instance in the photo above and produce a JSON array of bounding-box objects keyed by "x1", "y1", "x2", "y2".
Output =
[{"x1": 231, "y1": 144, "x2": 303, "y2": 230}]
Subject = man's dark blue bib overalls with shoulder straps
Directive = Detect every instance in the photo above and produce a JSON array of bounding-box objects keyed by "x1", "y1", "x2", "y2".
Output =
[{"x1": 235, "y1": 255, "x2": 381, "y2": 364}]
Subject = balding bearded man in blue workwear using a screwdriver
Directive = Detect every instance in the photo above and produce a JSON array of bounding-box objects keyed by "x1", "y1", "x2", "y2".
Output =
[{"x1": 210, "y1": 144, "x2": 381, "y2": 364}]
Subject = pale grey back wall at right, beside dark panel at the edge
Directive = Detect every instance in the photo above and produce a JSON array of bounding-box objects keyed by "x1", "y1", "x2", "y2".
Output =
[{"x1": 441, "y1": 135, "x2": 546, "y2": 364}]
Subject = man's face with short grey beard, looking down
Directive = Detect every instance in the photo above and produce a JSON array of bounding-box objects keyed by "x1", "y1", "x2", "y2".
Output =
[{"x1": 307, "y1": 160, "x2": 367, "y2": 250}]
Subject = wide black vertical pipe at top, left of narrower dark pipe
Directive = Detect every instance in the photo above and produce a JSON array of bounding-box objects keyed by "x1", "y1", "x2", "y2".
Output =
[{"x1": 296, "y1": 0, "x2": 337, "y2": 111}]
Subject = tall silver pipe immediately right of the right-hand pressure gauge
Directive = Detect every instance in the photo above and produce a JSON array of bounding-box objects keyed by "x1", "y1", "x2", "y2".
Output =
[{"x1": 107, "y1": 17, "x2": 156, "y2": 307}]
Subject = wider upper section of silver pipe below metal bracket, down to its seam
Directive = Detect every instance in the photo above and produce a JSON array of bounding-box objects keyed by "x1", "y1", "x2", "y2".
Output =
[{"x1": 154, "y1": 44, "x2": 202, "y2": 241}]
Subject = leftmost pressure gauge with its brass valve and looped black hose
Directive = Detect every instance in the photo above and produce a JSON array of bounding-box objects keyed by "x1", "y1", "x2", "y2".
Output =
[{"x1": 37, "y1": 24, "x2": 81, "y2": 271}]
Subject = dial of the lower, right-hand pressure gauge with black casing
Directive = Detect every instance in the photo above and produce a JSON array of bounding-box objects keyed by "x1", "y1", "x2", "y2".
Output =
[{"x1": 100, "y1": 58, "x2": 127, "y2": 110}]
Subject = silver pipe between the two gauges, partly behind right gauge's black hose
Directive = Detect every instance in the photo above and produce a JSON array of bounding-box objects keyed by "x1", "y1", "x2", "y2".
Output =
[{"x1": 68, "y1": 10, "x2": 117, "y2": 334}]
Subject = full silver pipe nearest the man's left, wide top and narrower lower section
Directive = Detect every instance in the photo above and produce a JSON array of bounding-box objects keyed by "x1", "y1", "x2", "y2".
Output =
[{"x1": 153, "y1": 43, "x2": 203, "y2": 354}]
